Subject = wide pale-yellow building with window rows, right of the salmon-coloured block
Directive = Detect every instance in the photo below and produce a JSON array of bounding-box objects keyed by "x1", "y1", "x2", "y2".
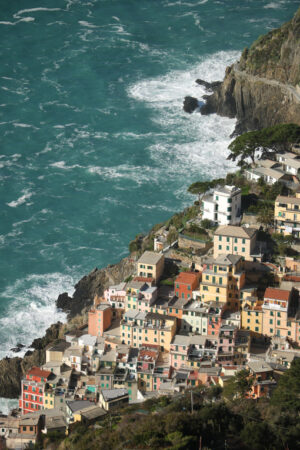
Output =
[{"x1": 120, "y1": 310, "x2": 177, "y2": 351}]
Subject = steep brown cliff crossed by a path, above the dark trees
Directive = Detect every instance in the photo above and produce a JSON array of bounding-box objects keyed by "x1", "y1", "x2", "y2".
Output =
[{"x1": 201, "y1": 9, "x2": 300, "y2": 133}]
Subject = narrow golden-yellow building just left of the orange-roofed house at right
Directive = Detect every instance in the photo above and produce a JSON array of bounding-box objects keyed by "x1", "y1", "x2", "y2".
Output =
[{"x1": 241, "y1": 297, "x2": 263, "y2": 334}]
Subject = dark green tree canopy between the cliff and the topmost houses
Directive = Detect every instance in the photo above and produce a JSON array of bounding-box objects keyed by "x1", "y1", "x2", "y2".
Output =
[{"x1": 227, "y1": 123, "x2": 300, "y2": 167}]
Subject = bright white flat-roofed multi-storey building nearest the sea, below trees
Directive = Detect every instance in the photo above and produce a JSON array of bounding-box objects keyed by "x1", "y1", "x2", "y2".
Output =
[{"x1": 201, "y1": 186, "x2": 241, "y2": 225}]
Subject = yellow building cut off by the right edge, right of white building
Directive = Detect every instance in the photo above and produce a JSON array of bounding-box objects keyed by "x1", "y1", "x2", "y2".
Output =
[{"x1": 274, "y1": 192, "x2": 300, "y2": 237}]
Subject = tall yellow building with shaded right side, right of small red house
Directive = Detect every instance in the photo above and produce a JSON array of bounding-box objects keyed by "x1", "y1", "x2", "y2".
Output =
[{"x1": 200, "y1": 255, "x2": 245, "y2": 309}]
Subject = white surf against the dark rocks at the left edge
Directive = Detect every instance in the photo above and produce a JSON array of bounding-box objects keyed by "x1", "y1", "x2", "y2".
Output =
[{"x1": 0, "y1": 273, "x2": 77, "y2": 358}]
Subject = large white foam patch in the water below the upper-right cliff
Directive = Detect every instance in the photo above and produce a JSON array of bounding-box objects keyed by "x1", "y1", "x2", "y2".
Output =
[{"x1": 128, "y1": 52, "x2": 239, "y2": 186}]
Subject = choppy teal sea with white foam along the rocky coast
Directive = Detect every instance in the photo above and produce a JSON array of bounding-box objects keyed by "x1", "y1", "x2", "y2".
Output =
[{"x1": 0, "y1": 0, "x2": 299, "y2": 410}]
